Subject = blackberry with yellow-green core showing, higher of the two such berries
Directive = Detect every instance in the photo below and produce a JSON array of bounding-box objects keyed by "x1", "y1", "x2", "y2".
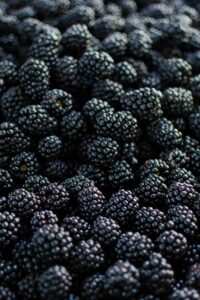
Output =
[{"x1": 40, "y1": 89, "x2": 72, "y2": 117}]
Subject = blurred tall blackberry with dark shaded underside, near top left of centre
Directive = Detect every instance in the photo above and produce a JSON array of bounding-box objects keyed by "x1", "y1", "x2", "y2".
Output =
[{"x1": 62, "y1": 24, "x2": 92, "y2": 56}]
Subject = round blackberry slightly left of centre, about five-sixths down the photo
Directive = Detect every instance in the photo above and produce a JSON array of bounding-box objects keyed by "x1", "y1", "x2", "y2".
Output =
[{"x1": 70, "y1": 239, "x2": 105, "y2": 274}]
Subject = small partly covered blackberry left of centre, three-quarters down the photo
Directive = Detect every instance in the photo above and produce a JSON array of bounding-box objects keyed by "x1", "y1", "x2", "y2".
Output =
[{"x1": 62, "y1": 216, "x2": 91, "y2": 242}]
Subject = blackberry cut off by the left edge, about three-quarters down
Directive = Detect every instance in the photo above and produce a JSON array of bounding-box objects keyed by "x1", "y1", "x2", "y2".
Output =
[{"x1": 0, "y1": 211, "x2": 21, "y2": 248}]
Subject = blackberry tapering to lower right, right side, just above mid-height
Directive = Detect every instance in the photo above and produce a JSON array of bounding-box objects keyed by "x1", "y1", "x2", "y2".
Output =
[{"x1": 148, "y1": 118, "x2": 182, "y2": 148}]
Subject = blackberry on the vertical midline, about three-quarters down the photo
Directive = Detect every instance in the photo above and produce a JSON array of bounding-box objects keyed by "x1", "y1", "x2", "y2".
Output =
[{"x1": 91, "y1": 216, "x2": 121, "y2": 246}]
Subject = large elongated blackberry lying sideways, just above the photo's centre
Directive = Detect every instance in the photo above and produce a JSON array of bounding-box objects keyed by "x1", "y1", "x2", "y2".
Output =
[{"x1": 94, "y1": 110, "x2": 138, "y2": 141}]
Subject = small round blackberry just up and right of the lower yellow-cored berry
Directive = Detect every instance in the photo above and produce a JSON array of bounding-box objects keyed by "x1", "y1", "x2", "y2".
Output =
[{"x1": 38, "y1": 135, "x2": 62, "y2": 159}]
